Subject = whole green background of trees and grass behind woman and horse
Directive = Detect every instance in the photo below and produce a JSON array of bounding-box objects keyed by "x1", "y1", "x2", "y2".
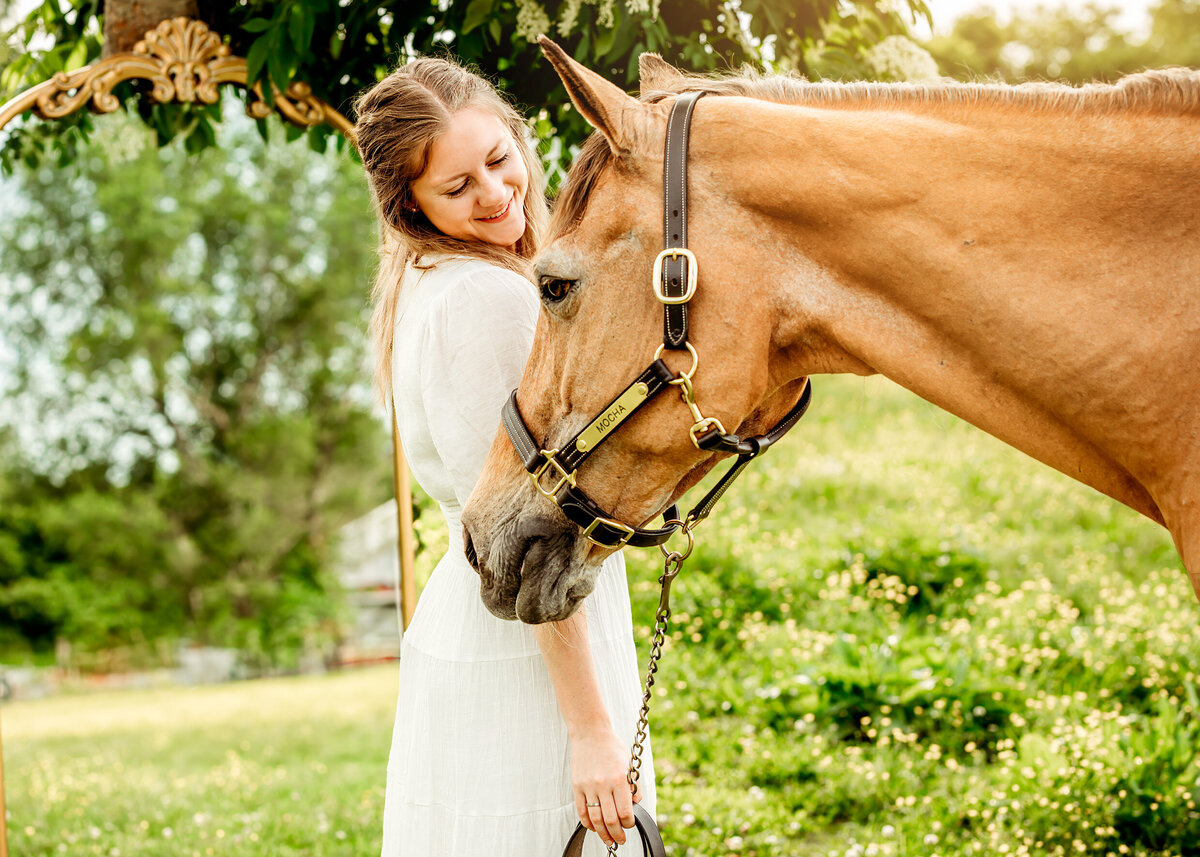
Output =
[{"x1": 0, "y1": 0, "x2": 1200, "y2": 857}]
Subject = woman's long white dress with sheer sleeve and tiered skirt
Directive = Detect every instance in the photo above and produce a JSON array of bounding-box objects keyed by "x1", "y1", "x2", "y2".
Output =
[{"x1": 383, "y1": 257, "x2": 654, "y2": 857}]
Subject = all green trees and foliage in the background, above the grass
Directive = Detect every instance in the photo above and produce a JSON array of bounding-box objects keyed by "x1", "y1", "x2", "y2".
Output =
[{"x1": 0, "y1": 0, "x2": 1200, "y2": 676}]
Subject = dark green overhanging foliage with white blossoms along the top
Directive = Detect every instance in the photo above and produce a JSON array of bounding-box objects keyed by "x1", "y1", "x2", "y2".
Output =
[{"x1": 0, "y1": 0, "x2": 928, "y2": 171}]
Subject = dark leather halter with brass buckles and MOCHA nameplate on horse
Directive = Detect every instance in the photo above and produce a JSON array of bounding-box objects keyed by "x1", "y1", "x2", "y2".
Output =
[{"x1": 503, "y1": 92, "x2": 812, "y2": 547}]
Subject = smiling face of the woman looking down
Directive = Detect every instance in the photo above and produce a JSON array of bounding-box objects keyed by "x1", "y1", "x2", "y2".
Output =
[{"x1": 413, "y1": 107, "x2": 529, "y2": 247}]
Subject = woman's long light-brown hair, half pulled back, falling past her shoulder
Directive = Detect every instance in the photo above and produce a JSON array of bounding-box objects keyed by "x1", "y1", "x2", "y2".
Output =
[{"x1": 354, "y1": 56, "x2": 548, "y2": 401}]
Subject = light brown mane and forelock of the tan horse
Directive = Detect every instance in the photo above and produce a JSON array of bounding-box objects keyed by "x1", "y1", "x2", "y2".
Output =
[{"x1": 551, "y1": 67, "x2": 1200, "y2": 234}]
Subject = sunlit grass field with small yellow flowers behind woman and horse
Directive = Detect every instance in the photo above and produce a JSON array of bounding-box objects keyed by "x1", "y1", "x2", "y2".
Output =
[{"x1": 2, "y1": 378, "x2": 1200, "y2": 857}]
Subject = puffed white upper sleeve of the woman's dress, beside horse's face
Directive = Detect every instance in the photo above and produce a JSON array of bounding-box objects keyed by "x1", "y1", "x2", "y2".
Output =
[{"x1": 421, "y1": 265, "x2": 538, "y2": 507}]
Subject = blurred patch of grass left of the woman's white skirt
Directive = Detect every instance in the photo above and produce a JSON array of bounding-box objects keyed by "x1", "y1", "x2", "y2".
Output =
[{"x1": 2, "y1": 666, "x2": 396, "y2": 857}]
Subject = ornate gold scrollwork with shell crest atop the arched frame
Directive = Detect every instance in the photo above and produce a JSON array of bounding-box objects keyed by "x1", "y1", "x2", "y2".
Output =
[{"x1": 0, "y1": 18, "x2": 352, "y2": 136}]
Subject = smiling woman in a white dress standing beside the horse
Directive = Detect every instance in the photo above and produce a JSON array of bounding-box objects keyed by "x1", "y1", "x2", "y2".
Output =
[{"x1": 355, "y1": 58, "x2": 654, "y2": 857}]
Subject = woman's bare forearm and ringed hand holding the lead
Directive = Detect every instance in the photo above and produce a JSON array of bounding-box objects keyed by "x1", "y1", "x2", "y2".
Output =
[{"x1": 534, "y1": 604, "x2": 640, "y2": 845}]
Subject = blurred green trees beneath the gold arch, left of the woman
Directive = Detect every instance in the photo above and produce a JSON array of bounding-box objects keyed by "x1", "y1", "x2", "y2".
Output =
[{"x1": 0, "y1": 103, "x2": 390, "y2": 657}]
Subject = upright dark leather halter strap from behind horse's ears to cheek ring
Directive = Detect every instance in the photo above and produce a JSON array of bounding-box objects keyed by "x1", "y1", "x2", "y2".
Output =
[{"x1": 661, "y1": 92, "x2": 703, "y2": 349}]
